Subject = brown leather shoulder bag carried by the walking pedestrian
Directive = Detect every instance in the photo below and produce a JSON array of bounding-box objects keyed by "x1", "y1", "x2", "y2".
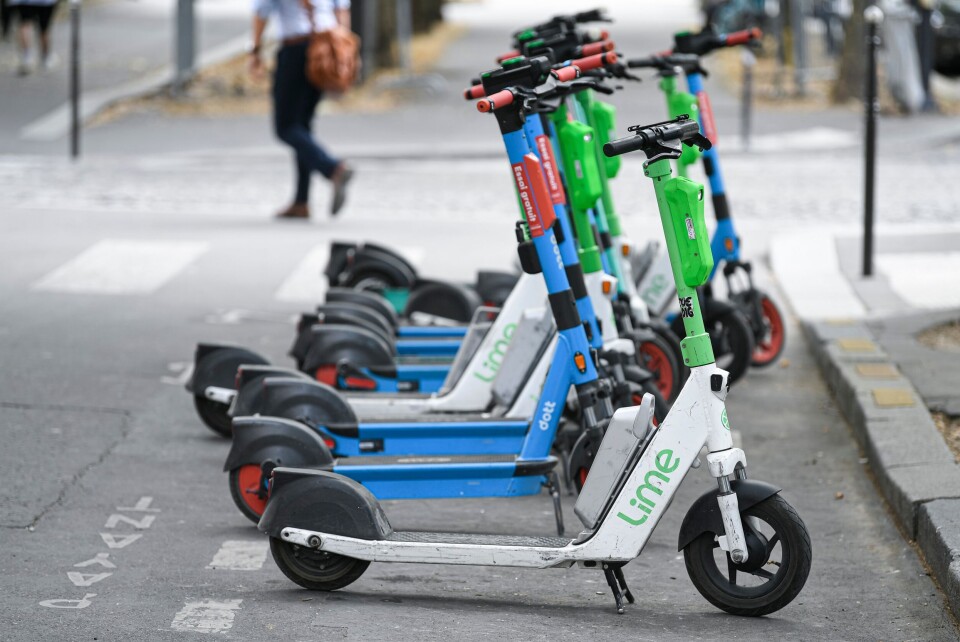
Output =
[{"x1": 303, "y1": 0, "x2": 360, "y2": 92}]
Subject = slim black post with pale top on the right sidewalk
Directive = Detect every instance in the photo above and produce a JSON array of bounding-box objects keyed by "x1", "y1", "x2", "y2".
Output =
[{"x1": 863, "y1": 5, "x2": 883, "y2": 277}]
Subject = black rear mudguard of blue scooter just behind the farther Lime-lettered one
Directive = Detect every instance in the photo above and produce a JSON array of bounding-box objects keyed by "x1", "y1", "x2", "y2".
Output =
[{"x1": 301, "y1": 324, "x2": 396, "y2": 385}]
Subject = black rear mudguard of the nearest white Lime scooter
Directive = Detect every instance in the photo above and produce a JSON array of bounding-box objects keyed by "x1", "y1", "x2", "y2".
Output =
[{"x1": 257, "y1": 467, "x2": 393, "y2": 540}]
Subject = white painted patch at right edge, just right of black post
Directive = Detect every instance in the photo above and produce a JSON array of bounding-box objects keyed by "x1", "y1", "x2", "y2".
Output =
[{"x1": 875, "y1": 252, "x2": 960, "y2": 308}]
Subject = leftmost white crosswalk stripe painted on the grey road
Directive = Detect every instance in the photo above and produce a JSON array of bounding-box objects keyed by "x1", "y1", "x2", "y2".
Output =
[{"x1": 33, "y1": 239, "x2": 207, "y2": 294}]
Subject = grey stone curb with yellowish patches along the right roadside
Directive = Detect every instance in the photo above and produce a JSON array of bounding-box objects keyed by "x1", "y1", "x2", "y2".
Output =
[{"x1": 802, "y1": 321, "x2": 960, "y2": 617}]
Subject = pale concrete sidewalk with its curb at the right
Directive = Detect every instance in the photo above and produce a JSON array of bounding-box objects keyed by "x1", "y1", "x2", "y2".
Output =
[{"x1": 771, "y1": 221, "x2": 960, "y2": 614}]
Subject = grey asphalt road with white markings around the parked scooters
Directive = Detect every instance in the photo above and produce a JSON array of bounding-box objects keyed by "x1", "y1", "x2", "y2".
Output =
[{"x1": 0, "y1": 149, "x2": 957, "y2": 640}]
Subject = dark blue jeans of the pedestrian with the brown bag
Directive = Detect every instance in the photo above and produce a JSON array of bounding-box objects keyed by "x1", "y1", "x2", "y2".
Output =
[{"x1": 273, "y1": 42, "x2": 340, "y2": 203}]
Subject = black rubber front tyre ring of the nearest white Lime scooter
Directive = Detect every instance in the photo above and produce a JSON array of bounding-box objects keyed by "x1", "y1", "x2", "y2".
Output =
[{"x1": 683, "y1": 495, "x2": 813, "y2": 617}]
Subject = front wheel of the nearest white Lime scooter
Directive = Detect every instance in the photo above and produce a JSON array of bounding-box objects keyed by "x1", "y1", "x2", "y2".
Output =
[{"x1": 683, "y1": 495, "x2": 813, "y2": 617}]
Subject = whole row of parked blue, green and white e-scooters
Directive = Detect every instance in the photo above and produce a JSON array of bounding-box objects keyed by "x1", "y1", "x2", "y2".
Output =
[{"x1": 187, "y1": 11, "x2": 811, "y2": 616}]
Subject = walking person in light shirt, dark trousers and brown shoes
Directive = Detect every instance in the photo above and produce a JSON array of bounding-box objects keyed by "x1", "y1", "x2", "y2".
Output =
[{"x1": 250, "y1": 0, "x2": 354, "y2": 219}]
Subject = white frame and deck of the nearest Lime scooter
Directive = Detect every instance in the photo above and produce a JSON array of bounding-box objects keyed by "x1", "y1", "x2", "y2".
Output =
[{"x1": 280, "y1": 364, "x2": 746, "y2": 568}]
